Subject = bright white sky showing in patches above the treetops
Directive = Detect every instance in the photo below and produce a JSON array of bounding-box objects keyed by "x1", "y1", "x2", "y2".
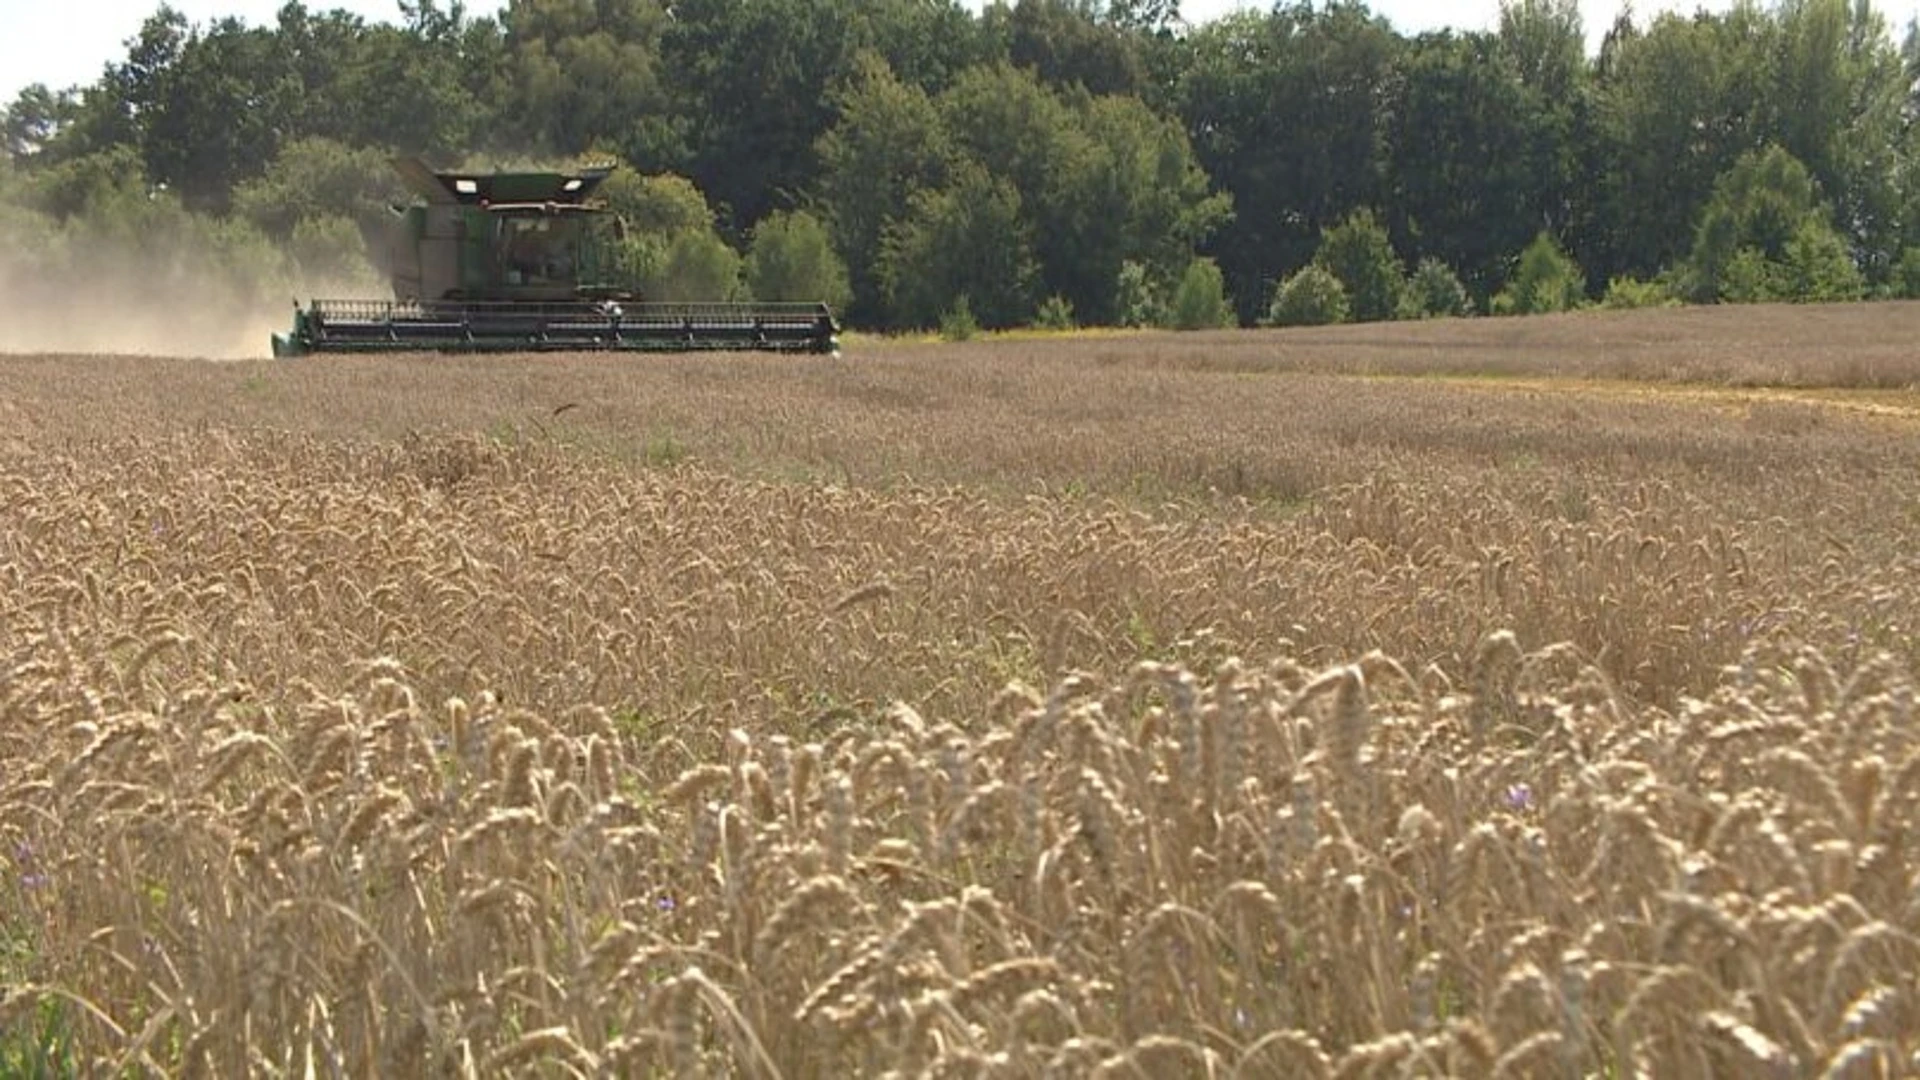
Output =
[{"x1": 0, "y1": 0, "x2": 1920, "y2": 104}]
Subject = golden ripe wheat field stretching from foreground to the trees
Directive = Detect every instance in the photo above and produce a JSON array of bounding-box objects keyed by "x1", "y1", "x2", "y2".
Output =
[{"x1": 0, "y1": 304, "x2": 1920, "y2": 1078}]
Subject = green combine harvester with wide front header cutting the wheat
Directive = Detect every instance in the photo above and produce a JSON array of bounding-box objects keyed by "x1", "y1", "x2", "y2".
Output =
[{"x1": 273, "y1": 158, "x2": 839, "y2": 356}]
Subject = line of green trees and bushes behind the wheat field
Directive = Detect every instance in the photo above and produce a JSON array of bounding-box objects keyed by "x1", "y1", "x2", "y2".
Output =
[{"x1": 0, "y1": 0, "x2": 1920, "y2": 329}]
